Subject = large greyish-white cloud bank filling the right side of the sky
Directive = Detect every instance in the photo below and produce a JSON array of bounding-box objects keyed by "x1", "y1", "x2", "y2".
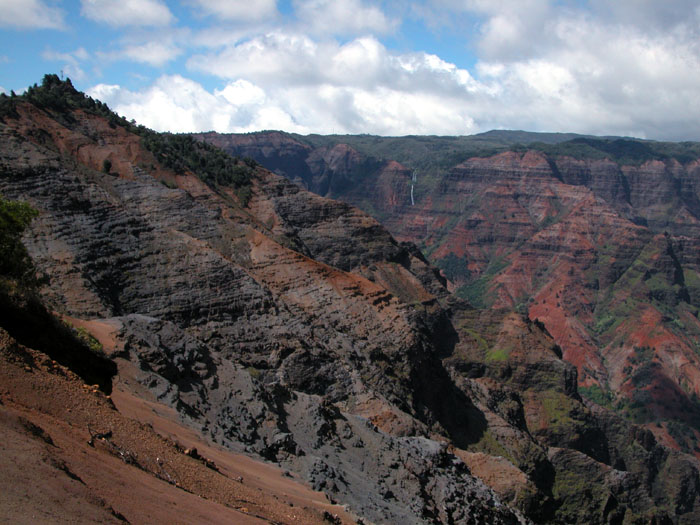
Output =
[{"x1": 400, "y1": 0, "x2": 700, "y2": 139}]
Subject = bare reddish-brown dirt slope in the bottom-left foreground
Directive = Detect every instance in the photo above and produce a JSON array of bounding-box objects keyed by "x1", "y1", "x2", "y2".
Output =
[{"x1": 0, "y1": 324, "x2": 354, "y2": 524}]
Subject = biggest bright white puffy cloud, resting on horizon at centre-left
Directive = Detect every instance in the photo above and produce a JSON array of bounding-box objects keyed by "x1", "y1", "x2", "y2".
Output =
[{"x1": 90, "y1": 33, "x2": 490, "y2": 135}]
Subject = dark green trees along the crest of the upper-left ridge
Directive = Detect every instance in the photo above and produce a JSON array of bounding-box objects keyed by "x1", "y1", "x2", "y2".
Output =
[{"x1": 0, "y1": 75, "x2": 257, "y2": 206}]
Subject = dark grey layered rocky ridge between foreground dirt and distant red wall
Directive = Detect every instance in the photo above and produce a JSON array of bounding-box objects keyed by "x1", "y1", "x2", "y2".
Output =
[{"x1": 0, "y1": 79, "x2": 700, "y2": 523}]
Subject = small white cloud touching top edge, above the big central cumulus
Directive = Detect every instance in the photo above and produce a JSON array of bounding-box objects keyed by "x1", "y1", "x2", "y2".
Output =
[{"x1": 293, "y1": 0, "x2": 399, "y2": 35}]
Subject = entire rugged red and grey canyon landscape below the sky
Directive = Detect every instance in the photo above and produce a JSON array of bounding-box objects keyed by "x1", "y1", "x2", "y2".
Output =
[{"x1": 0, "y1": 75, "x2": 700, "y2": 524}]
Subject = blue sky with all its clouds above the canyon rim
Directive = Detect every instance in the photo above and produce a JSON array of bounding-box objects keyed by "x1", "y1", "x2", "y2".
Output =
[{"x1": 0, "y1": 0, "x2": 700, "y2": 140}]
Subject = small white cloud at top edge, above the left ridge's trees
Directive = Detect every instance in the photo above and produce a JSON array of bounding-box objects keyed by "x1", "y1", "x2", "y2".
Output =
[{"x1": 80, "y1": 0, "x2": 174, "y2": 27}]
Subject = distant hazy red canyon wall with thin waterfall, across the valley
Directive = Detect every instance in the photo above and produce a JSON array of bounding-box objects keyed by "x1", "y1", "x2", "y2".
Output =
[{"x1": 197, "y1": 132, "x2": 700, "y2": 451}]
